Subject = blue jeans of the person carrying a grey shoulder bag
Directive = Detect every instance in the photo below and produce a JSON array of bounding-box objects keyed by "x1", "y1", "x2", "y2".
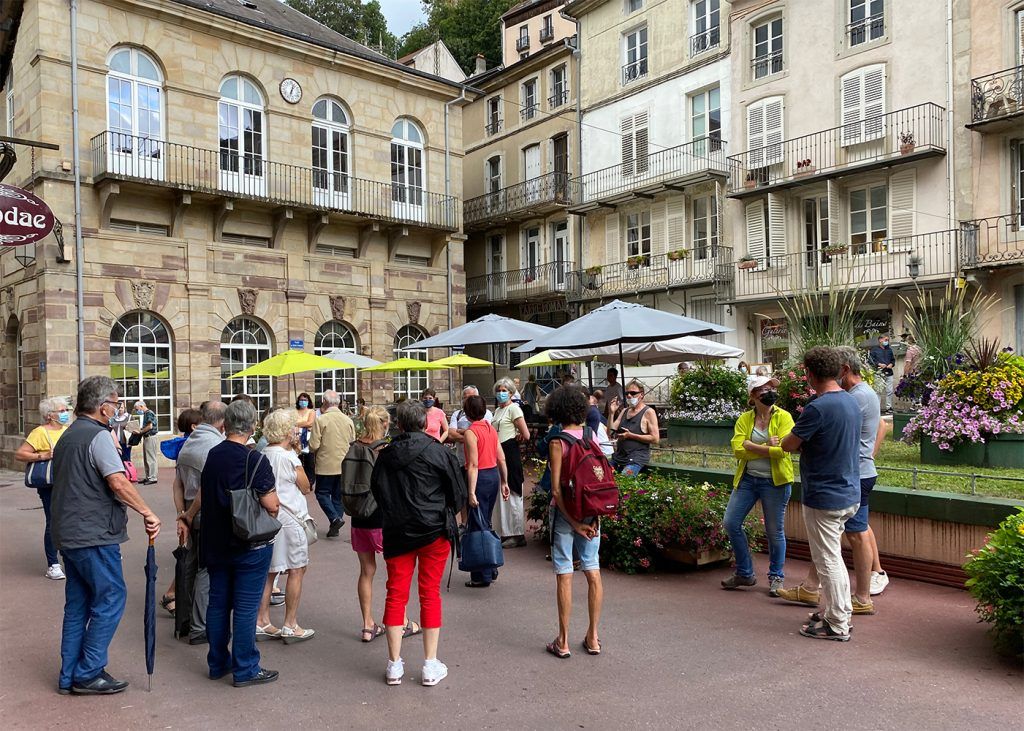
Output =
[{"x1": 206, "y1": 545, "x2": 273, "y2": 682}]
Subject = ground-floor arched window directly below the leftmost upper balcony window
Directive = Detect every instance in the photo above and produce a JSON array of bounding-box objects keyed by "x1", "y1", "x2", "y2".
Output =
[{"x1": 111, "y1": 311, "x2": 174, "y2": 433}]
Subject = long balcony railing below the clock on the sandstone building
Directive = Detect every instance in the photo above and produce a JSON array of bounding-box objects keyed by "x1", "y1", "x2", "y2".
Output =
[{"x1": 92, "y1": 132, "x2": 459, "y2": 230}]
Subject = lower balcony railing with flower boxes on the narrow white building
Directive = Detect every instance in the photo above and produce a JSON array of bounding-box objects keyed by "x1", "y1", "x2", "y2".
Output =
[{"x1": 568, "y1": 244, "x2": 733, "y2": 300}]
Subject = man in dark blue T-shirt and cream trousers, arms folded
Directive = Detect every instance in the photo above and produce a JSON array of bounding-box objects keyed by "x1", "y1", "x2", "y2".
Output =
[{"x1": 781, "y1": 347, "x2": 861, "y2": 642}]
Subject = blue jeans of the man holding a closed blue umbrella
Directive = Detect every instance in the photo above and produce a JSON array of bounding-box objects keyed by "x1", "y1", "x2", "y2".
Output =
[{"x1": 58, "y1": 544, "x2": 128, "y2": 688}]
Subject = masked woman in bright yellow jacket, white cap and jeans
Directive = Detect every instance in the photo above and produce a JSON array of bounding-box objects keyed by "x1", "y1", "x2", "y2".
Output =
[{"x1": 722, "y1": 376, "x2": 793, "y2": 597}]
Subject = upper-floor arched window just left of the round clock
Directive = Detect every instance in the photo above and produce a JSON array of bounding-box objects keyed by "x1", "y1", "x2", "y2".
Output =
[{"x1": 217, "y1": 75, "x2": 266, "y2": 196}]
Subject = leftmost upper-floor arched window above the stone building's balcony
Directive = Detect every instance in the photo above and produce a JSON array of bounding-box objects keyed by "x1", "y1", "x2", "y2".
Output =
[{"x1": 106, "y1": 48, "x2": 164, "y2": 177}]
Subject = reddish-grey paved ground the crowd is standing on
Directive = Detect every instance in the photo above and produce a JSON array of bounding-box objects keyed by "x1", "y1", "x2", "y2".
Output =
[{"x1": 0, "y1": 471, "x2": 1024, "y2": 729}]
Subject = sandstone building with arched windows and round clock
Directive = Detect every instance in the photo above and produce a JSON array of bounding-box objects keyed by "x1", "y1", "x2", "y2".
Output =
[{"x1": 0, "y1": 0, "x2": 465, "y2": 452}]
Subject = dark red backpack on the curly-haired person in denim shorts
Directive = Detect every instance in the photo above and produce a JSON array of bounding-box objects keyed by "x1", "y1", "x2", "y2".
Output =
[{"x1": 555, "y1": 429, "x2": 618, "y2": 520}]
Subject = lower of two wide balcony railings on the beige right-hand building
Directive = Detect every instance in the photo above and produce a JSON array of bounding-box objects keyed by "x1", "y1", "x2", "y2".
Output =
[{"x1": 733, "y1": 230, "x2": 958, "y2": 300}]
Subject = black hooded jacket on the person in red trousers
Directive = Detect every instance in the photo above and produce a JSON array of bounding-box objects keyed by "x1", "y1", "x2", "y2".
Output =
[{"x1": 370, "y1": 432, "x2": 467, "y2": 558}]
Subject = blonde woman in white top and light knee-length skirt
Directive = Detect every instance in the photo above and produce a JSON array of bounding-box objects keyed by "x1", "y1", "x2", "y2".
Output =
[{"x1": 256, "y1": 409, "x2": 314, "y2": 644}]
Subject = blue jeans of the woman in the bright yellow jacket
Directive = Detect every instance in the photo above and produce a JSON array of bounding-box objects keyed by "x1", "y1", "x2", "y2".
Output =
[{"x1": 725, "y1": 474, "x2": 793, "y2": 578}]
